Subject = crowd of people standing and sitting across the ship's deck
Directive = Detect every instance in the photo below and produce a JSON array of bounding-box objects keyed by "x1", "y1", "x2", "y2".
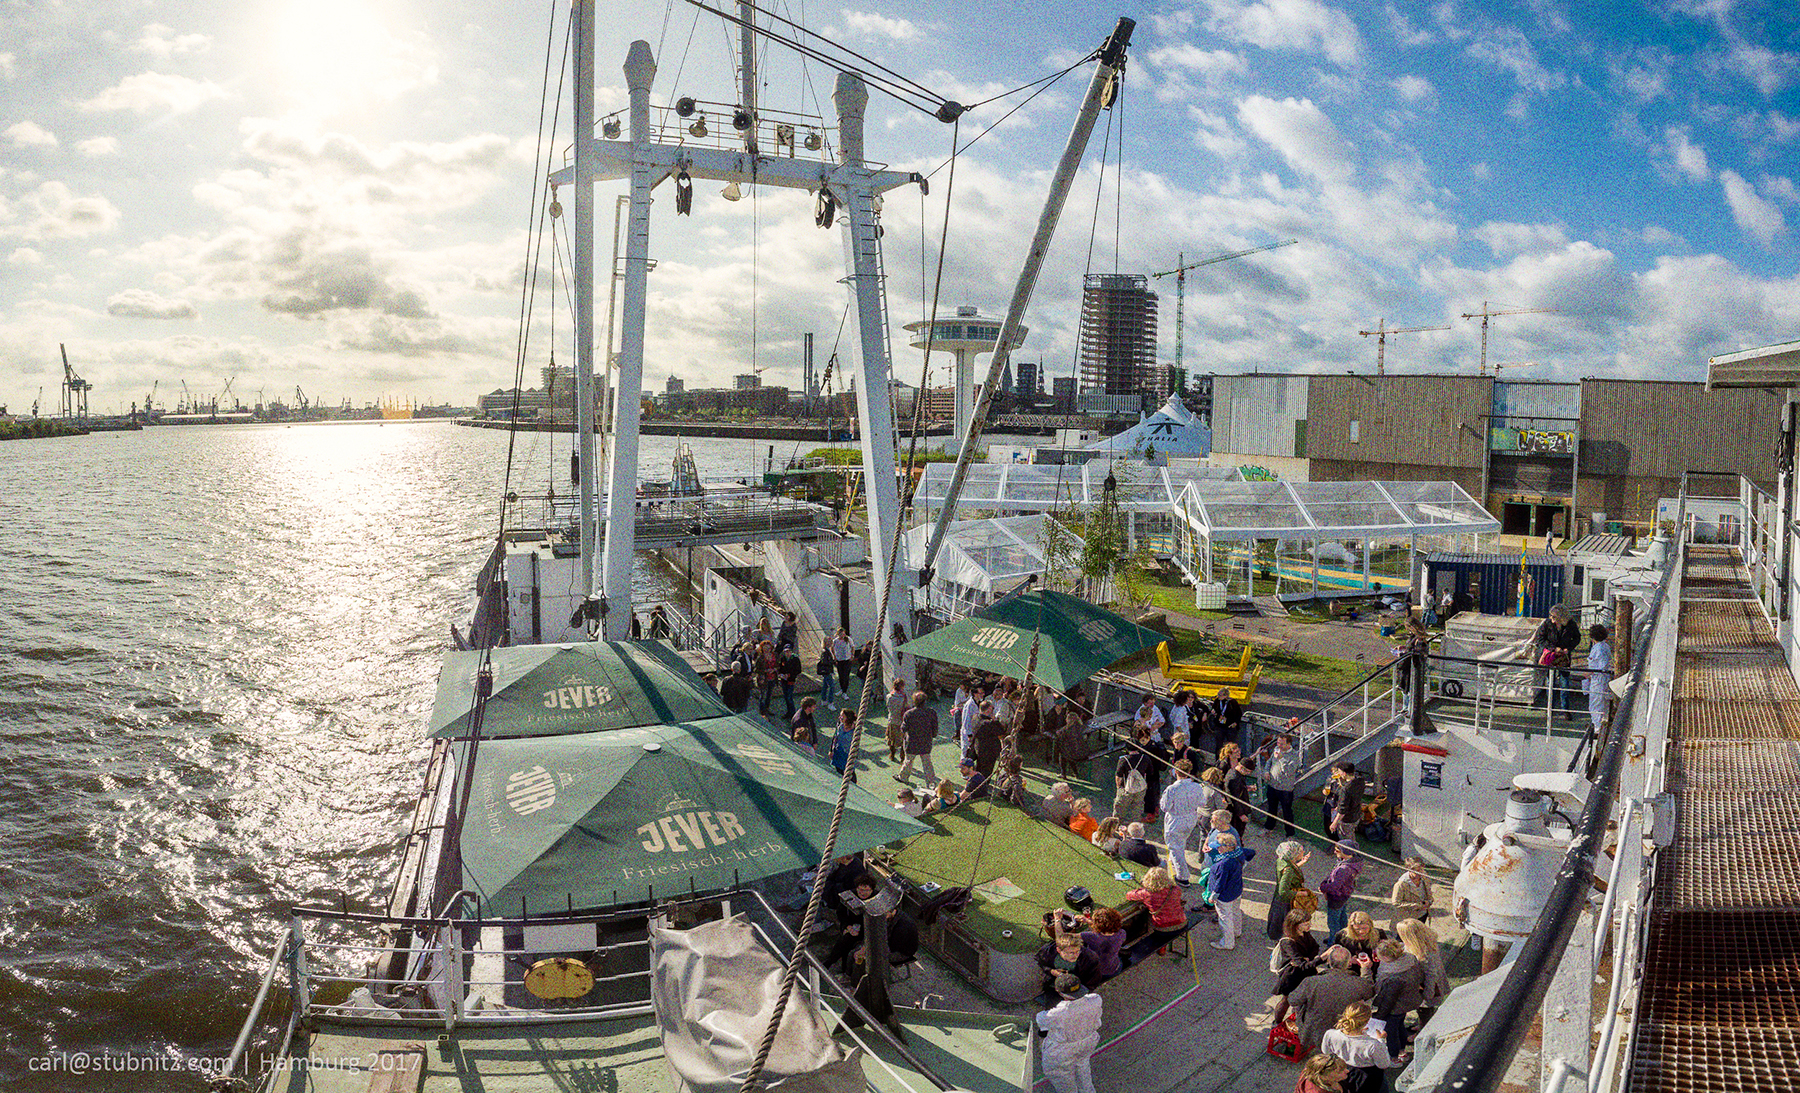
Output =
[{"x1": 720, "y1": 616, "x2": 1454, "y2": 1093}]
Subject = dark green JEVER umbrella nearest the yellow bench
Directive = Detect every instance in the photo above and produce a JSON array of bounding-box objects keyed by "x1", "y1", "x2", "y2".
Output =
[{"x1": 900, "y1": 589, "x2": 1165, "y2": 691}]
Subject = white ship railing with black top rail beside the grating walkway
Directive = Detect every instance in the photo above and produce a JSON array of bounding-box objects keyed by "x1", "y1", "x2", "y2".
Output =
[{"x1": 1418, "y1": 475, "x2": 1694, "y2": 1093}]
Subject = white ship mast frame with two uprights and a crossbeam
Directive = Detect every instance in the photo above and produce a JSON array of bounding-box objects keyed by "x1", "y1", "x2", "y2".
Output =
[{"x1": 551, "y1": 0, "x2": 925, "y2": 673}]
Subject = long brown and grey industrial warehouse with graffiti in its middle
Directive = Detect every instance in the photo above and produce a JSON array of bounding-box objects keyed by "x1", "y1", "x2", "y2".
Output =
[{"x1": 1211, "y1": 373, "x2": 1780, "y2": 537}]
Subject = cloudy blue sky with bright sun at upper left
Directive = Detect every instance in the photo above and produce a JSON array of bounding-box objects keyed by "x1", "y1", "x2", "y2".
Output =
[{"x1": 0, "y1": 0, "x2": 1800, "y2": 412}]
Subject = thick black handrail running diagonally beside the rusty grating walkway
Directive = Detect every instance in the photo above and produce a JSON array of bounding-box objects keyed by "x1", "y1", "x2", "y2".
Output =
[{"x1": 1438, "y1": 493, "x2": 1687, "y2": 1093}]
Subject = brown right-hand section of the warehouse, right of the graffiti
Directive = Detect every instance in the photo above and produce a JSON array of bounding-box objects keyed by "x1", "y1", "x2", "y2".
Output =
[{"x1": 1575, "y1": 380, "x2": 1782, "y2": 524}]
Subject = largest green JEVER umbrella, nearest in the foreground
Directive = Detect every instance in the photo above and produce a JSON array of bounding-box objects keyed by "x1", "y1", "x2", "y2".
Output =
[{"x1": 454, "y1": 715, "x2": 925, "y2": 915}]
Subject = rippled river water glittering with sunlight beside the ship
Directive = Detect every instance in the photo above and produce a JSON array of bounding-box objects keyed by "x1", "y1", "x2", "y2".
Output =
[{"x1": 0, "y1": 423, "x2": 964, "y2": 1089}]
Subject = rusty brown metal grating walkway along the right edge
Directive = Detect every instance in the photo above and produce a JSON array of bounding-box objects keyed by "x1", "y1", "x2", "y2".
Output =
[{"x1": 1631, "y1": 547, "x2": 1800, "y2": 1093}]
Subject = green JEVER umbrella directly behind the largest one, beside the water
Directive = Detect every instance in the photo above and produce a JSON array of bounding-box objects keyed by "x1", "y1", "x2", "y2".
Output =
[{"x1": 430, "y1": 641, "x2": 731, "y2": 740}]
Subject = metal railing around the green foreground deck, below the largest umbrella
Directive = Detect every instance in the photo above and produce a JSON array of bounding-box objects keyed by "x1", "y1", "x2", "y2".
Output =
[{"x1": 225, "y1": 890, "x2": 952, "y2": 1093}]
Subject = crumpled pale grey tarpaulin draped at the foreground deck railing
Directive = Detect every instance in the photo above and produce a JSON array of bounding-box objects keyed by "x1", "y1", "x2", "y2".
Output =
[{"x1": 650, "y1": 915, "x2": 864, "y2": 1093}]
